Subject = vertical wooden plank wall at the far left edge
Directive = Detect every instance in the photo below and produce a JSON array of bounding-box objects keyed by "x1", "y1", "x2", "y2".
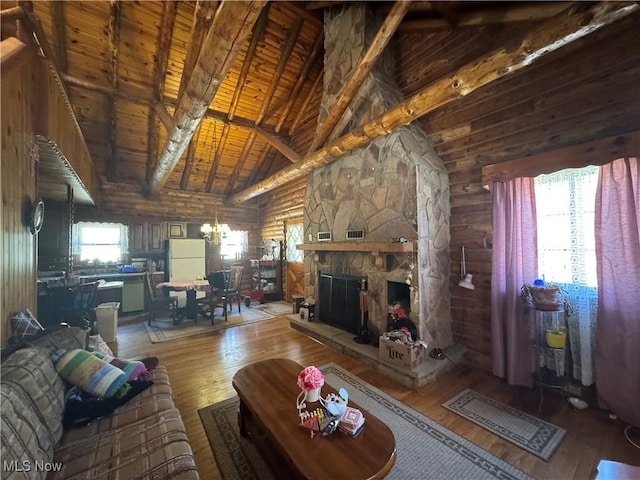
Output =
[{"x1": 0, "y1": 54, "x2": 37, "y2": 346}]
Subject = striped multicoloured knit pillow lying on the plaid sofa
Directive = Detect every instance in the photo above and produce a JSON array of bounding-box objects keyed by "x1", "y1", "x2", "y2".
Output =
[{"x1": 56, "y1": 349, "x2": 128, "y2": 398}]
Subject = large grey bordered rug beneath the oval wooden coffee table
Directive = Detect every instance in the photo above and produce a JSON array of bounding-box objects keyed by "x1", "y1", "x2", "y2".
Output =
[{"x1": 198, "y1": 363, "x2": 531, "y2": 480}]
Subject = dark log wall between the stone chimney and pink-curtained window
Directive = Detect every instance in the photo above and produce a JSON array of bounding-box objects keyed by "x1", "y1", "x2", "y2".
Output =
[{"x1": 396, "y1": 14, "x2": 640, "y2": 370}]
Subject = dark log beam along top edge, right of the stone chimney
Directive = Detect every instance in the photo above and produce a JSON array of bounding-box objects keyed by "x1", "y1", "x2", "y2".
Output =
[{"x1": 398, "y1": 2, "x2": 571, "y2": 32}]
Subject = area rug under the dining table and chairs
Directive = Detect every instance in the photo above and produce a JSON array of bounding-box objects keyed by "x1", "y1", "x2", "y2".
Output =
[{"x1": 144, "y1": 307, "x2": 274, "y2": 343}]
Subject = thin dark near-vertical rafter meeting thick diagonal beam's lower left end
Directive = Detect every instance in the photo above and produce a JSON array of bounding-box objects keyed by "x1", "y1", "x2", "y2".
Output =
[{"x1": 145, "y1": 1, "x2": 178, "y2": 180}]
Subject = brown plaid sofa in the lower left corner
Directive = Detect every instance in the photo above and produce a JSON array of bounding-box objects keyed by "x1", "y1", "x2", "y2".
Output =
[{"x1": 0, "y1": 327, "x2": 199, "y2": 480}]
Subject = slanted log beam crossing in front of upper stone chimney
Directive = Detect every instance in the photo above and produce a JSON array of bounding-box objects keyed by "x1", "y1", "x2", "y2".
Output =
[{"x1": 309, "y1": 1, "x2": 410, "y2": 152}]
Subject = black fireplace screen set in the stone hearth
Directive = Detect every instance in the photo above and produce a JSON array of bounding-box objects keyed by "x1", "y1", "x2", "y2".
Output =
[{"x1": 316, "y1": 272, "x2": 366, "y2": 335}]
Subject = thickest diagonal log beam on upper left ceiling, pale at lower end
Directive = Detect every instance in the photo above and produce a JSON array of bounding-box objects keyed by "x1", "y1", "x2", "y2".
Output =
[{"x1": 149, "y1": 0, "x2": 265, "y2": 195}]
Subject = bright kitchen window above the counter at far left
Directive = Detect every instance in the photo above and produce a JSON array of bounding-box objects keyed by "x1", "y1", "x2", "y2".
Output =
[{"x1": 73, "y1": 222, "x2": 129, "y2": 263}]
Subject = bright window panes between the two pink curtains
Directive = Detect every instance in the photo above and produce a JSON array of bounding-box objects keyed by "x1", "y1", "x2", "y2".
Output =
[{"x1": 535, "y1": 166, "x2": 598, "y2": 287}]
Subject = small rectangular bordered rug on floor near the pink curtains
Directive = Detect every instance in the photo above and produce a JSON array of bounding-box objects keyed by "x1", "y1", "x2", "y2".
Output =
[{"x1": 442, "y1": 390, "x2": 567, "y2": 460}]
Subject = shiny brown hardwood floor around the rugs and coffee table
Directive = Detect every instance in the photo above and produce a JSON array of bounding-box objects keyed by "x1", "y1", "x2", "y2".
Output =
[{"x1": 111, "y1": 317, "x2": 640, "y2": 480}]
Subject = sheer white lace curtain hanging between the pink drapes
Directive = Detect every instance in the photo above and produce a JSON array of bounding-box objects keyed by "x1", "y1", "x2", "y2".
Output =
[{"x1": 535, "y1": 167, "x2": 598, "y2": 385}]
